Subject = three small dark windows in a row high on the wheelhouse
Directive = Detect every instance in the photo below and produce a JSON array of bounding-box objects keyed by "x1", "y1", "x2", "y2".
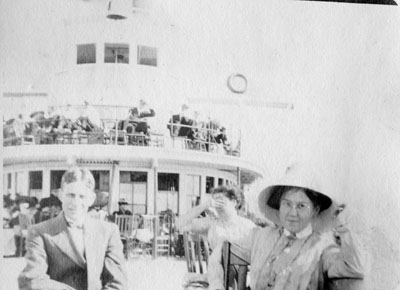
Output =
[{"x1": 76, "y1": 43, "x2": 157, "y2": 66}]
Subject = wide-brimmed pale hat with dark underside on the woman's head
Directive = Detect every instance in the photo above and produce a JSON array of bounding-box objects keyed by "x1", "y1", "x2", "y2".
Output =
[{"x1": 258, "y1": 165, "x2": 338, "y2": 232}]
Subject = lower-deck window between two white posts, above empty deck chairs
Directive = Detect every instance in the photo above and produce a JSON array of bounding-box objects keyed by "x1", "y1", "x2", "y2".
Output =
[{"x1": 119, "y1": 171, "x2": 147, "y2": 214}]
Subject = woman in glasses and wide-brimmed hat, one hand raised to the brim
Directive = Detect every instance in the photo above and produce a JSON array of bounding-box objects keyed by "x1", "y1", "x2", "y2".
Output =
[{"x1": 231, "y1": 168, "x2": 363, "y2": 290}]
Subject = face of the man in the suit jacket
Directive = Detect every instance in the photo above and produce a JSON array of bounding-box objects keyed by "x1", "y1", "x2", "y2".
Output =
[{"x1": 61, "y1": 182, "x2": 96, "y2": 222}]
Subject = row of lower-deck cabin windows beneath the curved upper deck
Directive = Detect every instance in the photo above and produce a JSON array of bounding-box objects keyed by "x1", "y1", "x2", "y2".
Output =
[{"x1": 7, "y1": 170, "x2": 232, "y2": 214}]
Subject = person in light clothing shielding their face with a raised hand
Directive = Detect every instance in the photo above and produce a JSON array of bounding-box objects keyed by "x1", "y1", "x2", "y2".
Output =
[{"x1": 176, "y1": 186, "x2": 255, "y2": 289}]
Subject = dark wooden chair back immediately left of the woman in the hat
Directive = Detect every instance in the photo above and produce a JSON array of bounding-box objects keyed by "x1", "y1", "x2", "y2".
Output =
[{"x1": 222, "y1": 242, "x2": 249, "y2": 290}]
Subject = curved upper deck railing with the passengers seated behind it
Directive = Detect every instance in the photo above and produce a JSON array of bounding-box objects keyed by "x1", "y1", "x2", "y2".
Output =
[{"x1": 3, "y1": 106, "x2": 240, "y2": 156}]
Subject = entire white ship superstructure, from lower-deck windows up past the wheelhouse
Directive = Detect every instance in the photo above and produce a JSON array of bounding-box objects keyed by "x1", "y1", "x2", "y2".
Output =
[{"x1": 3, "y1": 0, "x2": 262, "y2": 219}]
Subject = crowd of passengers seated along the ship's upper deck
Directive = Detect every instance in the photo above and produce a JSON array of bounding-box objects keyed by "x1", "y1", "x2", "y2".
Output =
[{"x1": 3, "y1": 99, "x2": 239, "y2": 154}]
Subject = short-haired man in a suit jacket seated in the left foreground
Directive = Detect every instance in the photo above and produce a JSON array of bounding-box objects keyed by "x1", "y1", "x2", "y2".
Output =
[{"x1": 18, "y1": 167, "x2": 127, "y2": 290}]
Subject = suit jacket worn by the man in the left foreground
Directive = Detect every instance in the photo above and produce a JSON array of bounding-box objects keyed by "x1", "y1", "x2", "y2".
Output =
[{"x1": 18, "y1": 213, "x2": 127, "y2": 290}]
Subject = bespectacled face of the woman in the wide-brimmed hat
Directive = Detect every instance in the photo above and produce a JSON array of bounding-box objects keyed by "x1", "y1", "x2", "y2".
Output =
[{"x1": 279, "y1": 189, "x2": 317, "y2": 233}]
